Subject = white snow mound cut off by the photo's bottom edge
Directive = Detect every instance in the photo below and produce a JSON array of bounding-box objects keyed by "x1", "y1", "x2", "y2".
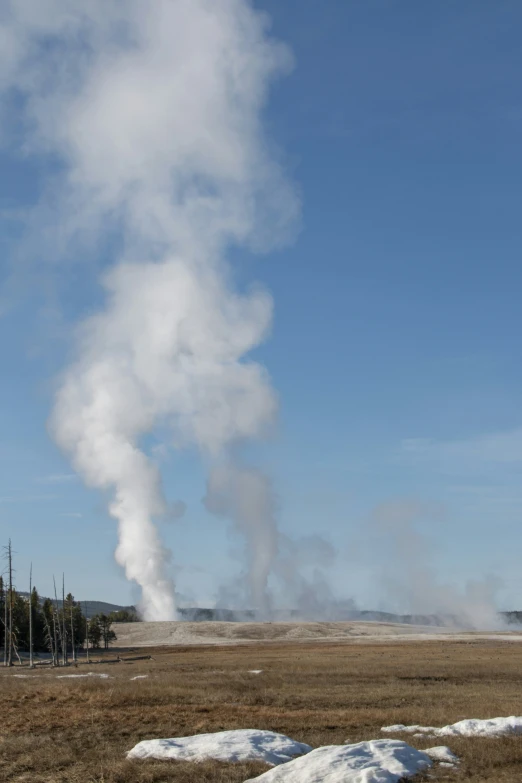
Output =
[{"x1": 242, "y1": 740, "x2": 432, "y2": 783}]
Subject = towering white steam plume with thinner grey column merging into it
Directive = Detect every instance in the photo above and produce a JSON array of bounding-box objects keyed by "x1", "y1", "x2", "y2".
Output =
[{"x1": 0, "y1": 0, "x2": 299, "y2": 620}]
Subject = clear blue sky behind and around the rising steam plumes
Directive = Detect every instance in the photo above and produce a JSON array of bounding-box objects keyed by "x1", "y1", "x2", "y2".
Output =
[{"x1": 0, "y1": 0, "x2": 522, "y2": 609}]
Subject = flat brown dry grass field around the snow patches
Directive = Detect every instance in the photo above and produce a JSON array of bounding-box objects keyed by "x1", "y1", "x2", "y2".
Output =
[{"x1": 0, "y1": 640, "x2": 522, "y2": 783}]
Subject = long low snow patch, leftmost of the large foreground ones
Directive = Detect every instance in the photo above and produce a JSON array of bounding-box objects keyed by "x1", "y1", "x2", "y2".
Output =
[{"x1": 127, "y1": 729, "x2": 310, "y2": 765}]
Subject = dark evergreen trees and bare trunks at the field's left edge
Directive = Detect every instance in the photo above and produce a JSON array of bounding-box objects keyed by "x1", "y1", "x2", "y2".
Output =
[{"x1": 0, "y1": 541, "x2": 117, "y2": 666}]
